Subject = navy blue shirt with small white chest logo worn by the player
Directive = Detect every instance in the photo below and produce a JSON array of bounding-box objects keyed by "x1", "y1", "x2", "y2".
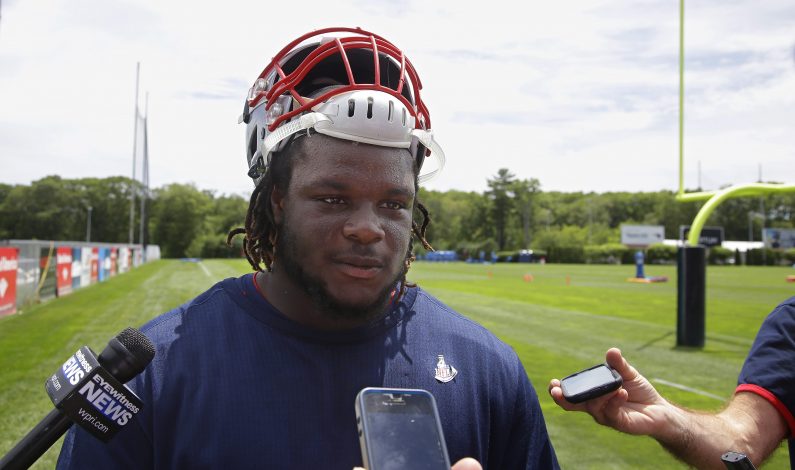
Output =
[{"x1": 58, "y1": 274, "x2": 558, "y2": 470}]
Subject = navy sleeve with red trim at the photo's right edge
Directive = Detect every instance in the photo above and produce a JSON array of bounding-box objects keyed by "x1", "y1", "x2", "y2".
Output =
[{"x1": 737, "y1": 297, "x2": 795, "y2": 469}]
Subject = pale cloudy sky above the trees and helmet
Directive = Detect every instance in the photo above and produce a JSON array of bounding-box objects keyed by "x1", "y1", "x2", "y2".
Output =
[{"x1": 0, "y1": 0, "x2": 795, "y2": 195}]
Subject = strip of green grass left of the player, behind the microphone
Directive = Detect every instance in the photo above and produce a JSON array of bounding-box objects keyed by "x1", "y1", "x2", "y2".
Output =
[{"x1": 0, "y1": 260, "x2": 246, "y2": 468}]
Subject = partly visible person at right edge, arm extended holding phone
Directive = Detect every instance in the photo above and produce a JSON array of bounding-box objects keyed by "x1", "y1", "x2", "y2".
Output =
[{"x1": 549, "y1": 297, "x2": 795, "y2": 469}]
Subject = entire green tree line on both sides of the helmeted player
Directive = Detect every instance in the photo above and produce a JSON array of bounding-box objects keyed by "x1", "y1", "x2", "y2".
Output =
[{"x1": 0, "y1": 173, "x2": 795, "y2": 257}]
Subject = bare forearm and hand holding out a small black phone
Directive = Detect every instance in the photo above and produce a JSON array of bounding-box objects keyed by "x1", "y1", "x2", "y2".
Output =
[{"x1": 549, "y1": 348, "x2": 787, "y2": 469}]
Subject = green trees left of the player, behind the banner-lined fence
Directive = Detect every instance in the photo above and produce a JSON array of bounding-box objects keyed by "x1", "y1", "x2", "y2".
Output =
[{"x1": 0, "y1": 176, "x2": 248, "y2": 258}]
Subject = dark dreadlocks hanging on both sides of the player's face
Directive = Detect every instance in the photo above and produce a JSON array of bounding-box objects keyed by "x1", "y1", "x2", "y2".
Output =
[{"x1": 226, "y1": 137, "x2": 433, "y2": 296}]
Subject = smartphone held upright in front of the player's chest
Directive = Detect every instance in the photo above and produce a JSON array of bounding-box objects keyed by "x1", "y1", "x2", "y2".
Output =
[{"x1": 356, "y1": 387, "x2": 450, "y2": 470}]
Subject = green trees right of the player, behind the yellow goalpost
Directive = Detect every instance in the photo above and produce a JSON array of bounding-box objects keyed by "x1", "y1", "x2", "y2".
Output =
[{"x1": 420, "y1": 169, "x2": 795, "y2": 254}]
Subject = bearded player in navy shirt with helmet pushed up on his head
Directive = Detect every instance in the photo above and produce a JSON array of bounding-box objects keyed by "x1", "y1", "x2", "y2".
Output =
[{"x1": 59, "y1": 28, "x2": 557, "y2": 470}]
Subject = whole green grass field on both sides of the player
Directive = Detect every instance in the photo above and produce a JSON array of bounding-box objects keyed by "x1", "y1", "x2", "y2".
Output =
[{"x1": 0, "y1": 260, "x2": 795, "y2": 469}]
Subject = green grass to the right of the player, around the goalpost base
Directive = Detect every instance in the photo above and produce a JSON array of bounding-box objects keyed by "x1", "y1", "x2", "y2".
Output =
[{"x1": 411, "y1": 263, "x2": 795, "y2": 469}]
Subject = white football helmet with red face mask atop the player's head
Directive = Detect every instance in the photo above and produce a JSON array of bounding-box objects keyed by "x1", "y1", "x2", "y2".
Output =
[{"x1": 239, "y1": 28, "x2": 445, "y2": 184}]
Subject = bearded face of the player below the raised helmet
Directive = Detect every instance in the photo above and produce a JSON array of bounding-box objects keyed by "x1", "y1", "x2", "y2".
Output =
[{"x1": 273, "y1": 135, "x2": 415, "y2": 318}]
